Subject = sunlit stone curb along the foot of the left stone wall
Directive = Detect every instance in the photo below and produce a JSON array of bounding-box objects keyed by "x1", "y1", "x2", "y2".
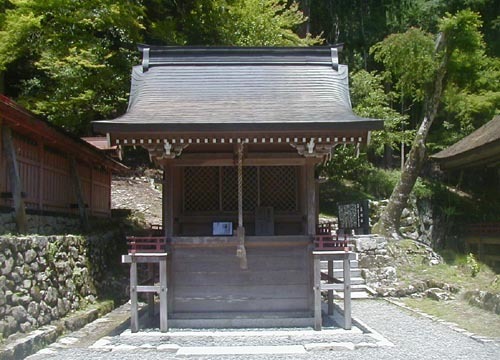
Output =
[{"x1": 0, "y1": 300, "x2": 114, "y2": 360}]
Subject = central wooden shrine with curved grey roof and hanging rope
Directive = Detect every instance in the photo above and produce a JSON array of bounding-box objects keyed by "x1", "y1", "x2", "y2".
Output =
[{"x1": 94, "y1": 46, "x2": 383, "y2": 327}]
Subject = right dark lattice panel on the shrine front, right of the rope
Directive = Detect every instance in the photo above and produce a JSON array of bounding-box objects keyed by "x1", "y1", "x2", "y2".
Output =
[{"x1": 260, "y1": 166, "x2": 297, "y2": 211}]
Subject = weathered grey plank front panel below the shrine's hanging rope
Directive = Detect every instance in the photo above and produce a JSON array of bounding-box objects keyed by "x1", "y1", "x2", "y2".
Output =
[{"x1": 171, "y1": 246, "x2": 311, "y2": 313}]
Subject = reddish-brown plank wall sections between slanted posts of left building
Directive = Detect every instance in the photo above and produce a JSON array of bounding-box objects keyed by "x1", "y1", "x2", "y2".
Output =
[{"x1": 0, "y1": 131, "x2": 111, "y2": 216}]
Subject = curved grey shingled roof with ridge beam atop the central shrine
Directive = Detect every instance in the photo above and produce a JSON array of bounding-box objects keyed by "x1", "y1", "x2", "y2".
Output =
[{"x1": 94, "y1": 45, "x2": 383, "y2": 133}]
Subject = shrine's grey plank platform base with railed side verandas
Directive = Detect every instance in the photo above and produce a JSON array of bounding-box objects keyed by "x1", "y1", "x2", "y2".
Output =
[{"x1": 122, "y1": 236, "x2": 357, "y2": 332}]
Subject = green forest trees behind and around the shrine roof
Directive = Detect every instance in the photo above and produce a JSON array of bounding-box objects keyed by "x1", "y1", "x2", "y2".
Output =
[{"x1": 0, "y1": 0, "x2": 500, "y2": 245}]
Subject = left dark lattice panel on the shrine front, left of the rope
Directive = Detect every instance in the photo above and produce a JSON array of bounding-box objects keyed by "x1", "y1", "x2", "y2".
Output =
[{"x1": 184, "y1": 166, "x2": 219, "y2": 211}]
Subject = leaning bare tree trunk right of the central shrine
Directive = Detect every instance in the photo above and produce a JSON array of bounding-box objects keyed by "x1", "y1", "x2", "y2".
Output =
[{"x1": 373, "y1": 34, "x2": 449, "y2": 238}]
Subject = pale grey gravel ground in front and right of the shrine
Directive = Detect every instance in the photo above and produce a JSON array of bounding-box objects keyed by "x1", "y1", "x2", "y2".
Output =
[{"x1": 29, "y1": 300, "x2": 500, "y2": 360}]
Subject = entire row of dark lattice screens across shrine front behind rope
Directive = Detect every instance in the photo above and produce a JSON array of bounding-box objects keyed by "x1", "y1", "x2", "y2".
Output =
[{"x1": 184, "y1": 166, "x2": 297, "y2": 212}]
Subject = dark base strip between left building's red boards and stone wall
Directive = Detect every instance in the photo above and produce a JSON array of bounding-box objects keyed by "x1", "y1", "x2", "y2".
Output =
[{"x1": 0, "y1": 213, "x2": 80, "y2": 235}]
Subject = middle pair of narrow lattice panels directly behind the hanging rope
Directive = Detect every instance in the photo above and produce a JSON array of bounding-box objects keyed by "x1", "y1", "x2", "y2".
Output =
[{"x1": 221, "y1": 166, "x2": 258, "y2": 211}]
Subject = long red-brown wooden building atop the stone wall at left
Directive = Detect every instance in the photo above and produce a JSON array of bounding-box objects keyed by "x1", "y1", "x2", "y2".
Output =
[{"x1": 0, "y1": 95, "x2": 125, "y2": 231}]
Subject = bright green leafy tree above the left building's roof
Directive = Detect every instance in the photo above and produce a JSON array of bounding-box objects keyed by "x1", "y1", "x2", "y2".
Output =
[{"x1": 0, "y1": 0, "x2": 143, "y2": 133}]
